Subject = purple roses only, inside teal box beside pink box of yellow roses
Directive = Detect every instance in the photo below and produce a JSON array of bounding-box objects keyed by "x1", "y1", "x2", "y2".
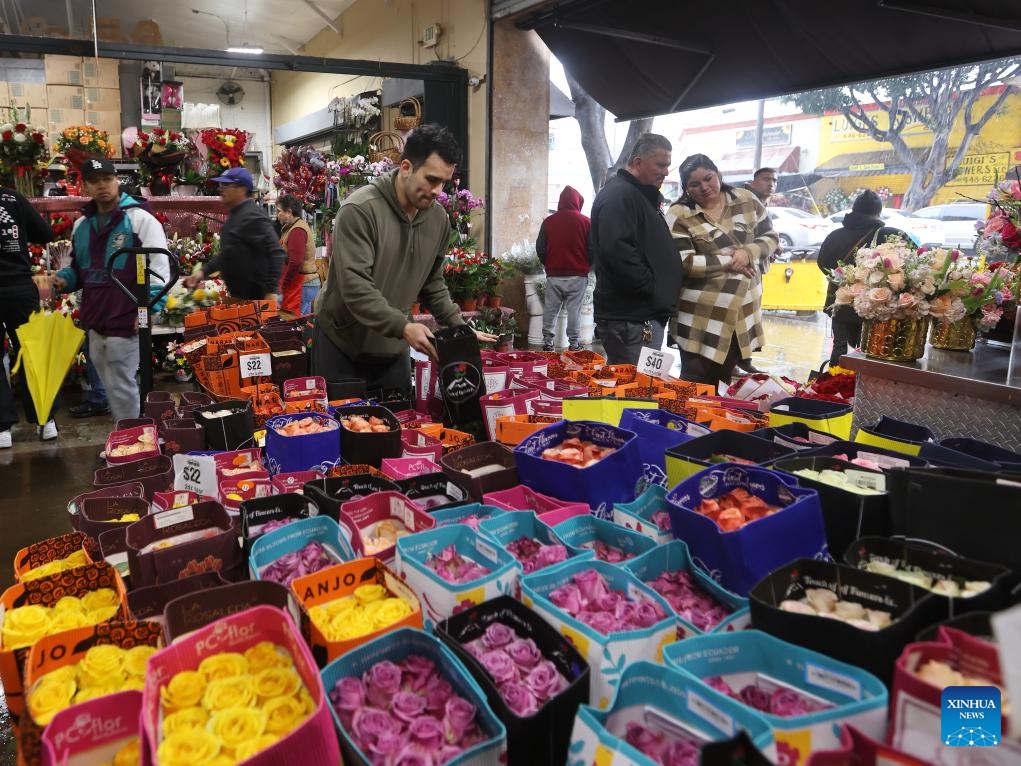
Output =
[{"x1": 329, "y1": 655, "x2": 486, "y2": 766}]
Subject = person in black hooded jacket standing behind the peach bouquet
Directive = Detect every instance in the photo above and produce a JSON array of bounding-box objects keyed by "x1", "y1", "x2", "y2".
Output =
[{"x1": 816, "y1": 189, "x2": 911, "y2": 366}]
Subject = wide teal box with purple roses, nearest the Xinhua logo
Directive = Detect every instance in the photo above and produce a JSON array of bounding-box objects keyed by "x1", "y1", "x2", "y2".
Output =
[{"x1": 663, "y1": 630, "x2": 887, "y2": 766}]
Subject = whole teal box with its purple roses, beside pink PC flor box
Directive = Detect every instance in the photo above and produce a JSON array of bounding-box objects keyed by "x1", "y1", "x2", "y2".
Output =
[{"x1": 323, "y1": 628, "x2": 506, "y2": 766}]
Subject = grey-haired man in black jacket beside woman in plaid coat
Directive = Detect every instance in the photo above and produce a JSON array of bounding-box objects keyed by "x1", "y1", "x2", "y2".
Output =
[{"x1": 588, "y1": 133, "x2": 683, "y2": 365}]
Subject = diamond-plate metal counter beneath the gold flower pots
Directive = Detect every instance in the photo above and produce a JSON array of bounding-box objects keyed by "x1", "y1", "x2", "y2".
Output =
[{"x1": 840, "y1": 341, "x2": 1021, "y2": 450}]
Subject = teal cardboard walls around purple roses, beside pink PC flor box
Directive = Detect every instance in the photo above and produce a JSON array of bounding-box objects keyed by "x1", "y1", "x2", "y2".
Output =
[{"x1": 323, "y1": 628, "x2": 506, "y2": 766}]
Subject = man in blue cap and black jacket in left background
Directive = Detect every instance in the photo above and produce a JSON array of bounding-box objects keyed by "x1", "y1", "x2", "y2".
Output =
[{"x1": 185, "y1": 167, "x2": 287, "y2": 300}]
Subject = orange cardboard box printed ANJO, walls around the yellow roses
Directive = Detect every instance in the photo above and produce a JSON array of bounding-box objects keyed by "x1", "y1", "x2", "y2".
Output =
[{"x1": 291, "y1": 559, "x2": 422, "y2": 668}]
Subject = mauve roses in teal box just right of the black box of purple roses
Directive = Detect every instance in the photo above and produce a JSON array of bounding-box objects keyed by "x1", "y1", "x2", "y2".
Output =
[{"x1": 549, "y1": 569, "x2": 667, "y2": 635}]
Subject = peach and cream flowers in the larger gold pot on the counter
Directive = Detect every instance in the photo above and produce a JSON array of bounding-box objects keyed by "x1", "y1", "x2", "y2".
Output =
[{"x1": 829, "y1": 237, "x2": 937, "y2": 321}]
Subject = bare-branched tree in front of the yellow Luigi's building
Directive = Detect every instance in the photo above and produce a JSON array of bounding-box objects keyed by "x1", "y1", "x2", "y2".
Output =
[{"x1": 787, "y1": 58, "x2": 1019, "y2": 210}]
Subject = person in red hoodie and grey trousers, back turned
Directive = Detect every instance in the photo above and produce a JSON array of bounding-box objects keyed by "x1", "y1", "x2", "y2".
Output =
[{"x1": 535, "y1": 186, "x2": 592, "y2": 351}]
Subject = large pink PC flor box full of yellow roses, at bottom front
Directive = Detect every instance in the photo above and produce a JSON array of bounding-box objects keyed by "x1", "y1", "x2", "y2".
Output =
[{"x1": 141, "y1": 607, "x2": 340, "y2": 766}]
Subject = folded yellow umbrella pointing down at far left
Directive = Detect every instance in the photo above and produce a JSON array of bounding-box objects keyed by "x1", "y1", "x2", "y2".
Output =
[{"x1": 11, "y1": 312, "x2": 85, "y2": 424}]
